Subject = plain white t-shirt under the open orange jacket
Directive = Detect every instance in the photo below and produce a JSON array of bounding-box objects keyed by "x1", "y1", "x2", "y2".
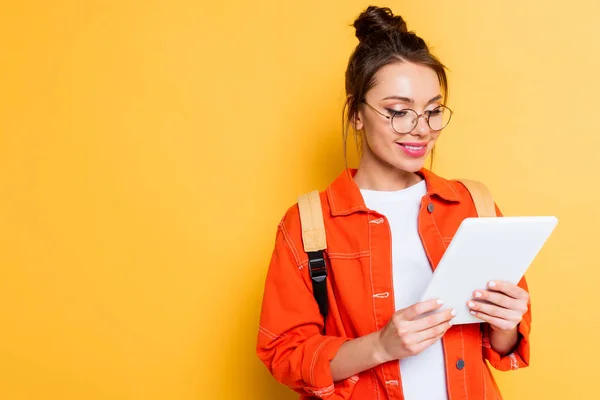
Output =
[{"x1": 361, "y1": 181, "x2": 448, "y2": 400}]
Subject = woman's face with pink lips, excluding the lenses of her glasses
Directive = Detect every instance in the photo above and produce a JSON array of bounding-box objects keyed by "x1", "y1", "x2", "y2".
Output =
[{"x1": 355, "y1": 62, "x2": 442, "y2": 172}]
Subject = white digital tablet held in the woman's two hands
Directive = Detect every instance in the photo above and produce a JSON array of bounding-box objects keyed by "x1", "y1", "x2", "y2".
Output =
[{"x1": 421, "y1": 217, "x2": 558, "y2": 325}]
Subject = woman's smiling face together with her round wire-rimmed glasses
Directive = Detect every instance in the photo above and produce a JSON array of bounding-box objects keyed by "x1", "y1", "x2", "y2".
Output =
[{"x1": 349, "y1": 61, "x2": 451, "y2": 180}]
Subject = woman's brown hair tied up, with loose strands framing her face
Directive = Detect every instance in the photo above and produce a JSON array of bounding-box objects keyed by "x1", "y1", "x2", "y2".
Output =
[{"x1": 342, "y1": 6, "x2": 448, "y2": 165}]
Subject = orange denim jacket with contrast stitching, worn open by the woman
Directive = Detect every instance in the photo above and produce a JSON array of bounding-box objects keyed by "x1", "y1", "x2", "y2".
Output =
[{"x1": 257, "y1": 169, "x2": 531, "y2": 400}]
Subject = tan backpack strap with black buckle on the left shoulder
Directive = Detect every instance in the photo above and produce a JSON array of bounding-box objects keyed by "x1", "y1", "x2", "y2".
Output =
[{"x1": 298, "y1": 190, "x2": 328, "y2": 323}]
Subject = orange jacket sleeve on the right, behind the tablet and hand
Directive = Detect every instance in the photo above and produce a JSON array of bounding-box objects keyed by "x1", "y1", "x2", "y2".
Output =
[{"x1": 481, "y1": 206, "x2": 531, "y2": 371}]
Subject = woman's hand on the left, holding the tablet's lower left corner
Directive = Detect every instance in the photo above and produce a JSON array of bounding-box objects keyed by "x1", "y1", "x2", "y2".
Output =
[{"x1": 376, "y1": 299, "x2": 456, "y2": 363}]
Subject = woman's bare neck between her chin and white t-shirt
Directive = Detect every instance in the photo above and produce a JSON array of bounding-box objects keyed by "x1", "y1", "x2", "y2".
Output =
[{"x1": 354, "y1": 160, "x2": 423, "y2": 191}]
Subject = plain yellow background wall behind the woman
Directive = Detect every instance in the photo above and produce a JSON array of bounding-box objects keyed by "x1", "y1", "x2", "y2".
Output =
[{"x1": 0, "y1": 0, "x2": 600, "y2": 400}]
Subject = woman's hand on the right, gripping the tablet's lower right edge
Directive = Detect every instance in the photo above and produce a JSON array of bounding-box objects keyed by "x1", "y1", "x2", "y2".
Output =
[{"x1": 467, "y1": 281, "x2": 529, "y2": 332}]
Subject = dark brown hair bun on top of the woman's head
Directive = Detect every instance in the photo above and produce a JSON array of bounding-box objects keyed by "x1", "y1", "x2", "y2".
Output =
[{"x1": 354, "y1": 6, "x2": 408, "y2": 42}]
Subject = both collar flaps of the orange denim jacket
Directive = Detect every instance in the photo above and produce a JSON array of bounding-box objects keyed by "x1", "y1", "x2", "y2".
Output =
[{"x1": 327, "y1": 168, "x2": 461, "y2": 216}]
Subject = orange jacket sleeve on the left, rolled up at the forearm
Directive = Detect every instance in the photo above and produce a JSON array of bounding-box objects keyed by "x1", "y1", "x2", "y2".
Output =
[{"x1": 256, "y1": 213, "x2": 358, "y2": 399}]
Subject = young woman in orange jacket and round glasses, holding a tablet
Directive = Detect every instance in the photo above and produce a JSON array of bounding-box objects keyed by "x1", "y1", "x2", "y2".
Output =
[{"x1": 257, "y1": 7, "x2": 531, "y2": 400}]
